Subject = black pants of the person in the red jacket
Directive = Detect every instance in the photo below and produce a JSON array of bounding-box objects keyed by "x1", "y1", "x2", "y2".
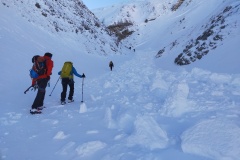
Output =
[{"x1": 32, "y1": 78, "x2": 48, "y2": 109}]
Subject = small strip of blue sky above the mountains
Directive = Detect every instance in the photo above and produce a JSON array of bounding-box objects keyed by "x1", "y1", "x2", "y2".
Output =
[{"x1": 82, "y1": 0, "x2": 128, "y2": 9}]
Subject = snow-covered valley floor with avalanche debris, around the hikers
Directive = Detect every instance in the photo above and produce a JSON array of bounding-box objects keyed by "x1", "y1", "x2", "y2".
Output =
[{"x1": 0, "y1": 0, "x2": 240, "y2": 160}]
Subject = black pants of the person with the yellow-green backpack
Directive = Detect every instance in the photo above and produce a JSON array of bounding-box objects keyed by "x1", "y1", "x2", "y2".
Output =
[{"x1": 61, "y1": 78, "x2": 74, "y2": 101}]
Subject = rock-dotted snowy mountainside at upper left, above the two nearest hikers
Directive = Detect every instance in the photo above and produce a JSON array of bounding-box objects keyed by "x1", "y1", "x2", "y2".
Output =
[{"x1": 1, "y1": 0, "x2": 121, "y2": 55}]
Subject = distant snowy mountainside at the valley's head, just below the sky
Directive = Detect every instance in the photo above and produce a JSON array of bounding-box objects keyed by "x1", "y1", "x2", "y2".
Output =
[{"x1": 93, "y1": 0, "x2": 175, "y2": 25}]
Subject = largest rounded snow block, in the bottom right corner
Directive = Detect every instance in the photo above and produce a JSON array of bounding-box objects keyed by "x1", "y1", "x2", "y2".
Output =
[{"x1": 181, "y1": 119, "x2": 240, "y2": 160}]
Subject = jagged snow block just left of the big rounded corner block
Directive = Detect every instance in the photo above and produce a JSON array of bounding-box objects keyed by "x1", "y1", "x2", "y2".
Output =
[{"x1": 128, "y1": 116, "x2": 168, "y2": 150}]
